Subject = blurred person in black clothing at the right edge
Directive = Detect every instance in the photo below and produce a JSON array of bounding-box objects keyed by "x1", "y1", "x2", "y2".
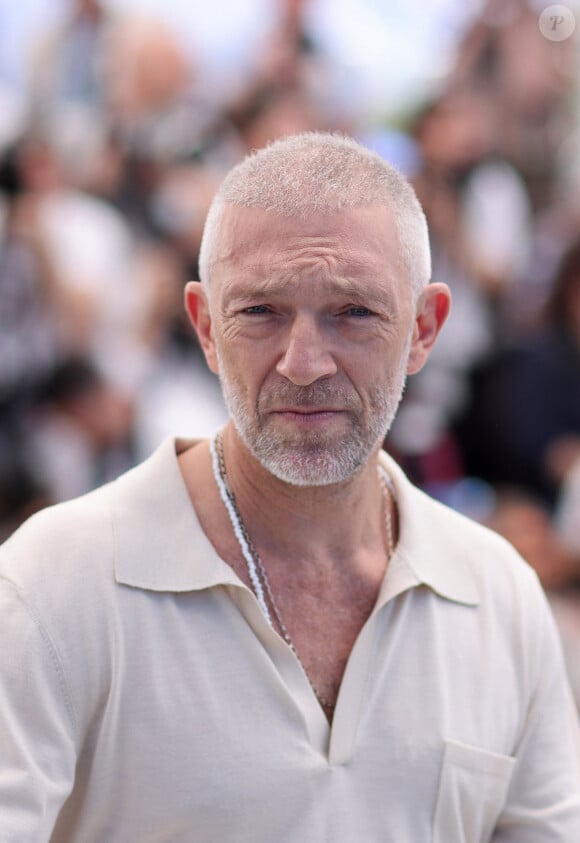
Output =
[{"x1": 460, "y1": 241, "x2": 580, "y2": 510}]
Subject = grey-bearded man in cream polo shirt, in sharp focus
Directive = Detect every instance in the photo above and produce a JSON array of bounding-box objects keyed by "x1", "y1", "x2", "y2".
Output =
[{"x1": 0, "y1": 134, "x2": 580, "y2": 843}]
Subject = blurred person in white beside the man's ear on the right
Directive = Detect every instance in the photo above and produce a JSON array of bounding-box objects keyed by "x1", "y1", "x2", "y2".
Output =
[{"x1": 388, "y1": 87, "x2": 531, "y2": 491}]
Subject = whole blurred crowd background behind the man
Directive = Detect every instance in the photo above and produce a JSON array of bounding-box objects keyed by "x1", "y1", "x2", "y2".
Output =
[{"x1": 0, "y1": 0, "x2": 580, "y2": 703}]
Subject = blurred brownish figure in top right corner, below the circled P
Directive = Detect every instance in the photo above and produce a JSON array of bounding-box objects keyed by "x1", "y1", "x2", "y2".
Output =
[{"x1": 449, "y1": 0, "x2": 577, "y2": 212}]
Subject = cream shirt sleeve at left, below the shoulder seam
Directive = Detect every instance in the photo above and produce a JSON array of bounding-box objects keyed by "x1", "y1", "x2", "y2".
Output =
[{"x1": 0, "y1": 578, "x2": 76, "y2": 843}]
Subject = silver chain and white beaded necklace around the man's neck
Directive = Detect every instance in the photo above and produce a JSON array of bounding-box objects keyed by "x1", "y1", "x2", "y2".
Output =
[{"x1": 210, "y1": 430, "x2": 394, "y2": 715}]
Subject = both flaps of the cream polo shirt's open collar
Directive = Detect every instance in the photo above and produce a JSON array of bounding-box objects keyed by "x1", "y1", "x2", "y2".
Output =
[{"x1": 109, "y1": 438, "x2": 479, "y2": 606}]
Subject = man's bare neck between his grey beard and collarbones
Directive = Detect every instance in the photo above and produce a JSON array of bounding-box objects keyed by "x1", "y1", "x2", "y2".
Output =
[{"x1": 218, "y1": 423, "x2": 384, "y2": 567}]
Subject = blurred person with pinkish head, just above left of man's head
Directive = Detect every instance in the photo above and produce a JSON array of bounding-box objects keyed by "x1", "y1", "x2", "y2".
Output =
[{"x1": 97, "y1": 14, "x2": 244, "y2": 239}]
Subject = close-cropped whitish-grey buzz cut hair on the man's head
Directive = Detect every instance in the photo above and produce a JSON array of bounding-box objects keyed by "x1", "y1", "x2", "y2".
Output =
[{"x1": 199, "y1": 132, "x2": 431, "y2": 297}]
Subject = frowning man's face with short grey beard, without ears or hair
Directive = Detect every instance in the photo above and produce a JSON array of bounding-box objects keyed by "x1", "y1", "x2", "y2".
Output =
[{"x1": 203, "y1": 206, "x2": 422, "y2": 486}]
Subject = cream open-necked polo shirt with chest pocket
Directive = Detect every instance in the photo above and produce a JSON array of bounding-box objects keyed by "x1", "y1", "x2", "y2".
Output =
[{"x1": 0, "y1": 440, "x2": 580, "y2": 843}]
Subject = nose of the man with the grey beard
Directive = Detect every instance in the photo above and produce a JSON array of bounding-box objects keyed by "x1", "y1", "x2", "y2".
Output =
[{"x1": 276, "y1": 316, "x2": 337, "y2": 386}]
